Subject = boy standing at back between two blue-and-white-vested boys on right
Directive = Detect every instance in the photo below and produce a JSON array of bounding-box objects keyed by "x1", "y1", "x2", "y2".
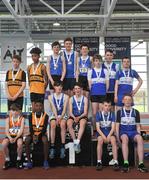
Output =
[{"x1": 102, "y1": 49, "x2": 119, "y2": 111}]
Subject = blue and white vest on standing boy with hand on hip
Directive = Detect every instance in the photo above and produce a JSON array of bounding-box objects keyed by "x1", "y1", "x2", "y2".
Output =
[{"x1": 118, "y1": 70, "x2": 134, "y2": 95}]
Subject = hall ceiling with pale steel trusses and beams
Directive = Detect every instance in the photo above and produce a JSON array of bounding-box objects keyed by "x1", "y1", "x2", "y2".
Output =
[{"x1": 0, "y1": 0, "x2": 149, "y2": 41}]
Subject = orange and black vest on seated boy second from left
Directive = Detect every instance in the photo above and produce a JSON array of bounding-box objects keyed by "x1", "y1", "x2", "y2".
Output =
[{"x1": 32, "y1": 113, "x2": 46, "y2": 136}]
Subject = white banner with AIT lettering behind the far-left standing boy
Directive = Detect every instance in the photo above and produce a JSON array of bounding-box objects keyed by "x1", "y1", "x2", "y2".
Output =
[{"x1": 1, "y1": 38, "x2": 27, "y2": 71}]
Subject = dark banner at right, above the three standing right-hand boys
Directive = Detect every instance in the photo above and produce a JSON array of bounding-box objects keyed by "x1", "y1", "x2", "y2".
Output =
[{"x1": 105, "y1": 37, "x2": 131, "y2": 59}]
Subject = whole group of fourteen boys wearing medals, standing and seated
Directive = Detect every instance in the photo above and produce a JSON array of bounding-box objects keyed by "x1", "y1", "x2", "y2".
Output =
[{"x1": 2, "y1": 38, "x2": 147, "y2": 172}]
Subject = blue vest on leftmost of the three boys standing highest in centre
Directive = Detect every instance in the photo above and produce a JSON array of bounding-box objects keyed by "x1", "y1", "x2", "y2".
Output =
[{"x1": 50, "y1": 56, "x2": 63, "y2": 76}]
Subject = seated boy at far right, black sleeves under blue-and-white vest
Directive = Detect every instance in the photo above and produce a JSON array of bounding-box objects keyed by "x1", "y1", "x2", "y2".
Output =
[{"x1": 116, "y1": 94, "x2": 148, "y2": 172}]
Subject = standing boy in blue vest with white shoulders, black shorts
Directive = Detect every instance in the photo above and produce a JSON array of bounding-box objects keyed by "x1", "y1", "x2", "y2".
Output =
[{"x1": 88, "y1": 55, "x2": 109, "y2": 134}]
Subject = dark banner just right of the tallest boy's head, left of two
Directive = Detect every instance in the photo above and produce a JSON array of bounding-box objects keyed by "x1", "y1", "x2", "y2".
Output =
[{"x1": 73, "y1": 37, "x2": 99, "y2": 56}]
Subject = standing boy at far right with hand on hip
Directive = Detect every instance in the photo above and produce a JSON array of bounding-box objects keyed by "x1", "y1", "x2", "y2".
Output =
[{"x1": 114, "y1": 57, "x2": 143, "y2": 109}]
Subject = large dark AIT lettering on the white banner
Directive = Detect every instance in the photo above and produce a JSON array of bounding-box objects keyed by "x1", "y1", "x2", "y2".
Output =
[{"x1": 3, "y1": 46, "x2": 24, "y2": 63}]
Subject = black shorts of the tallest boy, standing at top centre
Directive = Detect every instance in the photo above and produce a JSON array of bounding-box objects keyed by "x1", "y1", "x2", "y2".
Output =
[{"x1": 63, "y1": 78, "x2": 76, "y2": 91}]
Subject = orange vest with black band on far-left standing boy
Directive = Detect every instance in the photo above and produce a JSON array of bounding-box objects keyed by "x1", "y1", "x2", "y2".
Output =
[{"x1": 7, "y1": 69, "x2": 23, "y2": 97}]
